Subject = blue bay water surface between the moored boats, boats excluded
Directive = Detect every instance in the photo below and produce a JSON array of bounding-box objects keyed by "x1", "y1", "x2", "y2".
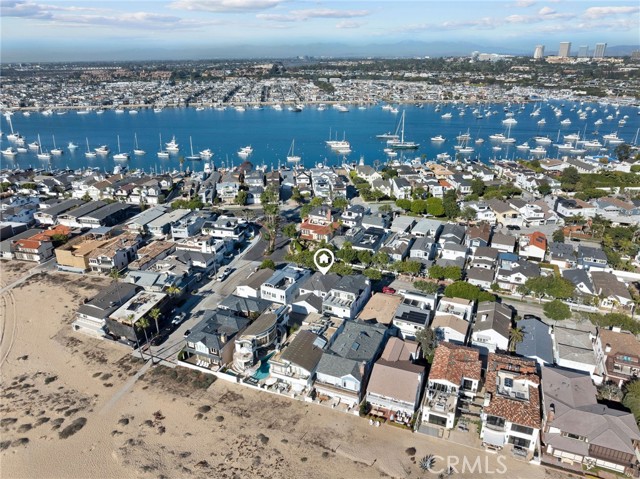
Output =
[{"x1": 2, "y1": 101, "x2": 640, "y2": 171}]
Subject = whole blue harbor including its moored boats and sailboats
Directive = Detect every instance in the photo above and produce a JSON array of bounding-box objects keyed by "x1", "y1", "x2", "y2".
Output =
[{"x1": 0, "y1": 100, "x2": 640, "y2": 170}]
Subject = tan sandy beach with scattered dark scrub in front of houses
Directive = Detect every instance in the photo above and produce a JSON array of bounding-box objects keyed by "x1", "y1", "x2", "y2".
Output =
[{"x1": 0, "y1": 262, "x2": 566, "y2": 479}]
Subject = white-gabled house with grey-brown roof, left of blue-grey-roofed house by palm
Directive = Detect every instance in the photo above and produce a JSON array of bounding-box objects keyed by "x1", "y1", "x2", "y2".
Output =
[{"x1": 471, "y1": 301, "x2": 513, "y2": 356}]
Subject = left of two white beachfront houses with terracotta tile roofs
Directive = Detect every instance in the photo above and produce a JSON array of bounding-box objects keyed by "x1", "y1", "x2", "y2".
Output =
[{"x1": 422, "y1": 342, "x2": 482, "y2": 429}]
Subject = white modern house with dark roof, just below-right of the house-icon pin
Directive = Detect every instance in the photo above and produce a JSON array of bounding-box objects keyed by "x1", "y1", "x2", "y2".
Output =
[{"x1": 322, "y1": 275, "x2": 371, "y2": 319}]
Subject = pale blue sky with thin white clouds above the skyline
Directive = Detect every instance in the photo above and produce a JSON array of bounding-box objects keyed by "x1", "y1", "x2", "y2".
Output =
[{"x1": 0, "y1": 0, "x2": 640, "y2": 62}]
